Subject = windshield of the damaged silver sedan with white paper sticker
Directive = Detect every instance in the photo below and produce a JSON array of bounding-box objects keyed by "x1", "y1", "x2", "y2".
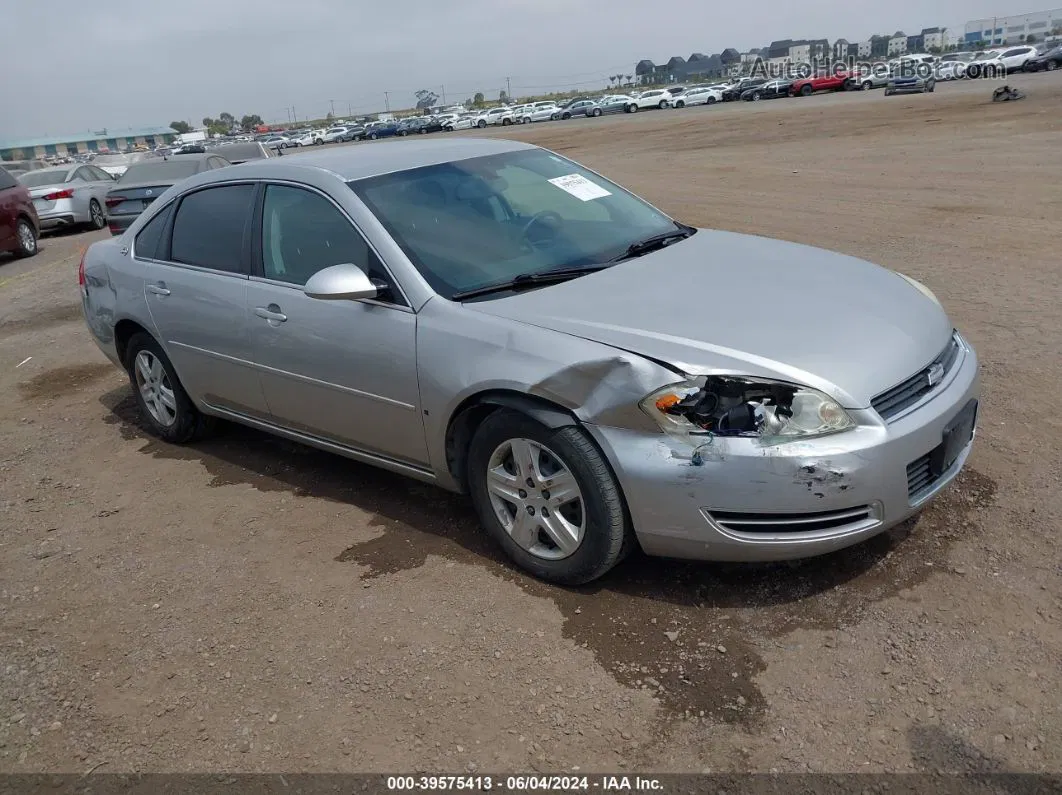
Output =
[{"x1": 349, "y1": 150, "x2": 680, "y2": 298}]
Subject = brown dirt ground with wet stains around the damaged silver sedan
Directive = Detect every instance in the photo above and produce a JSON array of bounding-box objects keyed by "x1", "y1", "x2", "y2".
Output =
[{"x1": 0, "y1": 73, "x2": 1062, "y2": 773}]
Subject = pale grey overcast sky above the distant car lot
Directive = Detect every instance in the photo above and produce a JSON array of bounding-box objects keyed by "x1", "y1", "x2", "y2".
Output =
[{"x1": 0, "y1": 0, "x2": 1052, "y2": 141}]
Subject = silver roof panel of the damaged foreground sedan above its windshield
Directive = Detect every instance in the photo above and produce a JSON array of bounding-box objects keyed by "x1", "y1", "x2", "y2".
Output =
[{"x1": 227, "y1": 136, "x2": 536, "y2": 180}]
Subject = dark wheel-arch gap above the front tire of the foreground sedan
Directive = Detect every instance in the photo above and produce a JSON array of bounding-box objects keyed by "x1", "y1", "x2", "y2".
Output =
[{"x1": 446, "y1": 388, "x2": 580, "y2": 492}]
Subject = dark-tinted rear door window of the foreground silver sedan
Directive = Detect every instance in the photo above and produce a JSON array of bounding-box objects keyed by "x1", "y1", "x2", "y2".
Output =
[{"x1": 170, "y1": 185, "x2": 255, "y2": 273}]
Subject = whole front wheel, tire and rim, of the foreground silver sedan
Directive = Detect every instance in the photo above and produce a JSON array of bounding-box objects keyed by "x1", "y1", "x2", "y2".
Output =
[{"x1": 468, "y1": 410, "x2": 631, "y2": 585}]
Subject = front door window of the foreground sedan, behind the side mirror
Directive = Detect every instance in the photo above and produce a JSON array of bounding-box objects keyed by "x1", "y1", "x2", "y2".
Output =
[{"x1": 262, "y1": 185, "x2": 383, "y2": 287}]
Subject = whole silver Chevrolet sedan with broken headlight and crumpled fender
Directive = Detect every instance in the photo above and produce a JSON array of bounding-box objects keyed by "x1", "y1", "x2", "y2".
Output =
[{"x1": 80, "y1": 138, "x2": 978, "y2": 584}]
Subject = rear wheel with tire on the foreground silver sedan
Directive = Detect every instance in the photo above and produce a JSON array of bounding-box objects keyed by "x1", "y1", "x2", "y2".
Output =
[{"x1": 125, "y1": 333, "x2": 213, "y2": 445}]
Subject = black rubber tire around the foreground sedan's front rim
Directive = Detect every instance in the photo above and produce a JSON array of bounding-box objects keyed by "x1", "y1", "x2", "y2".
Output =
[{"x1": 467, "y1": 410, "x2": 633, "y2": 585}]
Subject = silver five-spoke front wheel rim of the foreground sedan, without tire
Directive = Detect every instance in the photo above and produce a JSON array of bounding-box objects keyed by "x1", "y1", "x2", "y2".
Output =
[{"x1": 486, "y1": 438, "x2": 586, "y2": 560}]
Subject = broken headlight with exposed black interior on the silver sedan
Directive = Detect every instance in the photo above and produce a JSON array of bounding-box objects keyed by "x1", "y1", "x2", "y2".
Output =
[{"x1": 641, "y1": 376, "x2": 855, "y2": 446}]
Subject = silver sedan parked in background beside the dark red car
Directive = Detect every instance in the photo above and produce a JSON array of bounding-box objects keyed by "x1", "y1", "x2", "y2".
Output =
[{"x1": 19, "y1": 165, "x2": 115, "y2": 229}]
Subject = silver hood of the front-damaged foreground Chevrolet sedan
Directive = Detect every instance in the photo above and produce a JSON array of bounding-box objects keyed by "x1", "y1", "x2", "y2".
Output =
[{"x1": 465, "y1": 229, "x2": 953, "y2": 409}]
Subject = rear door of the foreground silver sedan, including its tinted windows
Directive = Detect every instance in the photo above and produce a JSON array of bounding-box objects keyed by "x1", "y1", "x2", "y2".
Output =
[{"x1": 140, "y1": 183, "x2": 267, "y2": 418}]
